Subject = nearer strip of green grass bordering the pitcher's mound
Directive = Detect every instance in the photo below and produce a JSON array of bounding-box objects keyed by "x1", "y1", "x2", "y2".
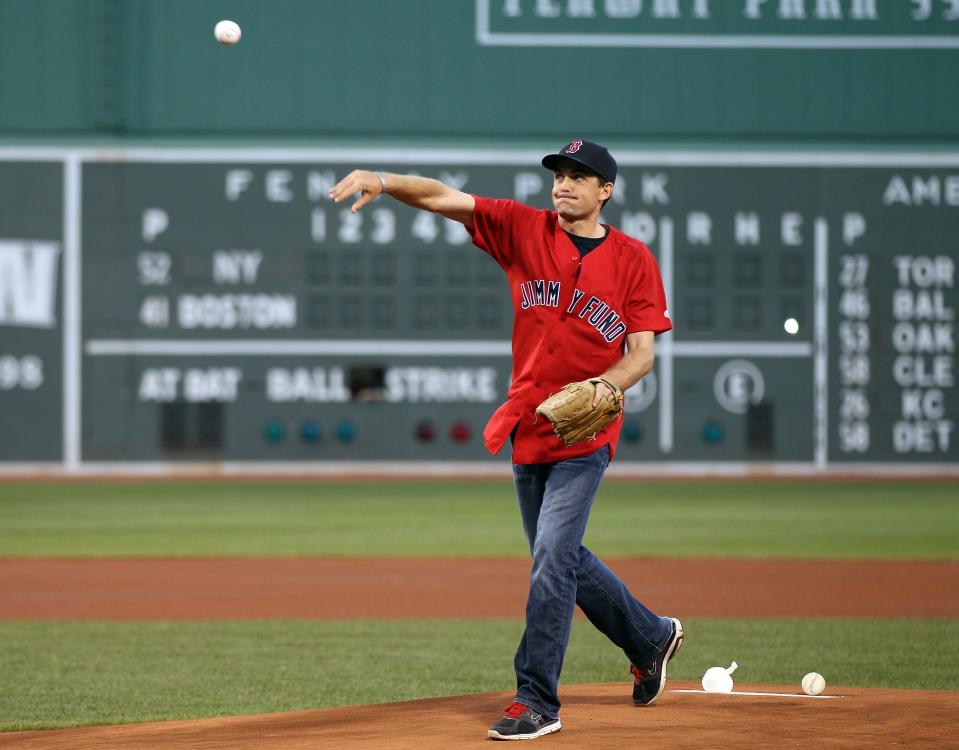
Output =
[{"x1": 0, "y1": 619, "x2": 959, "y2": 731}]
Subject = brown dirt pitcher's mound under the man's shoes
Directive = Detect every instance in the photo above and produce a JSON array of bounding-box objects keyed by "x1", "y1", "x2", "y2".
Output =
[{"x1": 0, "y1": 681, "x2": 959, "y2": 750}]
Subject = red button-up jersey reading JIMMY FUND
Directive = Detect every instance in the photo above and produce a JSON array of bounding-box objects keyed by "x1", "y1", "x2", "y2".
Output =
[{"x1": 472, "y1": 196, "x2": 672, "y2": 464}]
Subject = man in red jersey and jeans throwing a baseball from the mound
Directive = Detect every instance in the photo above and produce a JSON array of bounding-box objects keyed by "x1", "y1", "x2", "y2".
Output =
[{"x1": 330, "y1": 140, "x2": 684, "y2": 740}]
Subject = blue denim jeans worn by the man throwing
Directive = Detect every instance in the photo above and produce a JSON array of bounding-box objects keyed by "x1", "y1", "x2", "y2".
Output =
[{"x1": 513, "y1": 446, "x2": 672, "y2": 718}]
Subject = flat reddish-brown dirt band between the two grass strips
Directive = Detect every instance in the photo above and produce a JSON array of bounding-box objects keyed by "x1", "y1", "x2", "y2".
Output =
[{"x1": 0, "y1": 558, "x2": 959, "y2": 620}]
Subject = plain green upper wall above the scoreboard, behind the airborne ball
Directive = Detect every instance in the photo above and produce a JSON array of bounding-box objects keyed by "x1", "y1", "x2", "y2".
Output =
[{"x1": 0, "y1": 0, "x2": 959, "y2": 143}]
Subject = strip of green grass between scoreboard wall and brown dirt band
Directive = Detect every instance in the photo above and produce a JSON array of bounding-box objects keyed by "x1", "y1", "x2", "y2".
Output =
[{"x1": 0, "y1": 479, "x2": 959, "y2": 560}]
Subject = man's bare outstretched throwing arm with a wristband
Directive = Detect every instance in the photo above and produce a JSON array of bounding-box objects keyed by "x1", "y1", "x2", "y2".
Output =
[{"x1": 330, "y1": 169, "x2": 476, "y2": 229}]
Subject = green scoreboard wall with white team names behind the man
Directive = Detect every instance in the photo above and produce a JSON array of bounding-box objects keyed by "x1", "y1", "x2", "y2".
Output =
[{"x1": 0, "y1": 148, "x2": 959, "y2": 469}]
